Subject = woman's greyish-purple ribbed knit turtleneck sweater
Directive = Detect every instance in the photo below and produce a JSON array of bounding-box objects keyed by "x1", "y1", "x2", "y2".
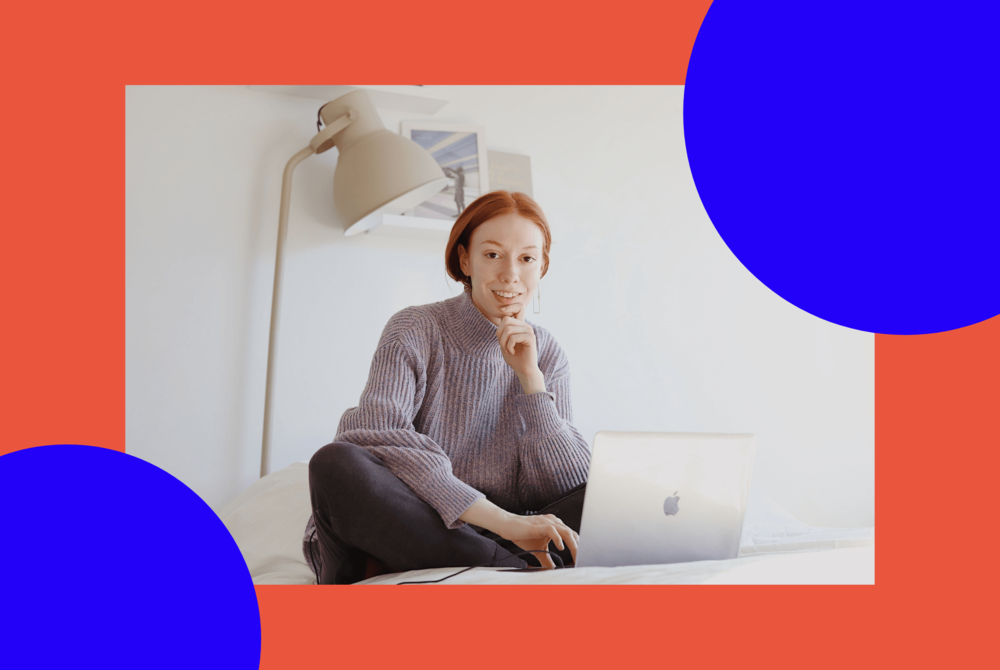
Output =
[{"x1": 310, "y1": 293, "x2": 590, "y2": 528}]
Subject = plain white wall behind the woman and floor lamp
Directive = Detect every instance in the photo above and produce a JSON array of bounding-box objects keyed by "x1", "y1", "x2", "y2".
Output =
[{"x1": 125, "y1": 86, "x2": 874, "y2": 526}]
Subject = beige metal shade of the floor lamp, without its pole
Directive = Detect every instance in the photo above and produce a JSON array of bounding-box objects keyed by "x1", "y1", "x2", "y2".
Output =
[{"x1": 320, "y1": 90, "x2": 449, "y2": 235}]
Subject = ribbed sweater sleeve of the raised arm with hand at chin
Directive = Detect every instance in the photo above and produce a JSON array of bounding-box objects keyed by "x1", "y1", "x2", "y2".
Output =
[{"x1": 517, "y1": 330, "x2": 590, "y2": 511}]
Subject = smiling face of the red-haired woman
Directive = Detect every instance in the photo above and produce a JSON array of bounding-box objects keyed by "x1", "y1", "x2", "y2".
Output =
[{"x1": 458, "y1": 214, "x2": 544, "y2": 326}]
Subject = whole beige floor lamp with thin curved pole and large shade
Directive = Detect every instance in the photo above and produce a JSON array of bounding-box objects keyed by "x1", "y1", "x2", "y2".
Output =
[{"x1": 260, "y1": 90, "x2": 449, "y2": 477}]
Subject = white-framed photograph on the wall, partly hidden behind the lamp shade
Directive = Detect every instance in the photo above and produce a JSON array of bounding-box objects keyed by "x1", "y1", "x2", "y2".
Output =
[{"x1": 400, "y1": 121, "x2": 490, "y2": 221}]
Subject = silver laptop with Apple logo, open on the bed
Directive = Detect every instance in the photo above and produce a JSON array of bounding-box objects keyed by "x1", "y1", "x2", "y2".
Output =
[{"x1": 576, "y1": 431, "x2": 757, "y2": 567}]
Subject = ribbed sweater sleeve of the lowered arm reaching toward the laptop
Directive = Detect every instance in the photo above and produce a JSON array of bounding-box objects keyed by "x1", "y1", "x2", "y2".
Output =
[{"x1": 337, "y1": 338, "x2": 485, "y2": 528}]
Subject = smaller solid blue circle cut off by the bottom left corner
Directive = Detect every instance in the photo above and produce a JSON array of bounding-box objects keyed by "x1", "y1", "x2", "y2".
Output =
[{"x1": 0, "y1": 445, "x2": 260, "y2": 670}]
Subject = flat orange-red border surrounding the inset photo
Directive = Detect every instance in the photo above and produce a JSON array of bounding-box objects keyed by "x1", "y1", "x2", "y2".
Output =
[{"x1": 0, "y1": 0, "x2": 1000, "y2": 668}]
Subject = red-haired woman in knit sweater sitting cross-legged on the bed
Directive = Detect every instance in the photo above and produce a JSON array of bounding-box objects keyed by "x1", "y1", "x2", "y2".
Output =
[{"x1": 303, "y1": 191, "x2": 590, "y2": 584}]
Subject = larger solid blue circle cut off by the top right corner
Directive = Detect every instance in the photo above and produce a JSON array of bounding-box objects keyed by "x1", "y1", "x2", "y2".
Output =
[{"x1": 684, "y1": 0, "x2": 1000, "y2": 335}]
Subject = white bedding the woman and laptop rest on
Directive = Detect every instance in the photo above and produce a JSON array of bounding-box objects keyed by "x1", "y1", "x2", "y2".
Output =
[{"x1": 219, "y1": 462, "x2": 875, "y2": 585}]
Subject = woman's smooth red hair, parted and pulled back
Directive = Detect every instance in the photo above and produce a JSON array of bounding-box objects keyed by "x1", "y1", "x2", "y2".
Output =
[{"x1": 444, "y1": 191, "x2": 552, "y2": 292}]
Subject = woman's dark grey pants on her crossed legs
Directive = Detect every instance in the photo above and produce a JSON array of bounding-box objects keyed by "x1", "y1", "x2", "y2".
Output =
[{"x1": 303, "y1": 442, "x2": 586, "y2": 584}]
